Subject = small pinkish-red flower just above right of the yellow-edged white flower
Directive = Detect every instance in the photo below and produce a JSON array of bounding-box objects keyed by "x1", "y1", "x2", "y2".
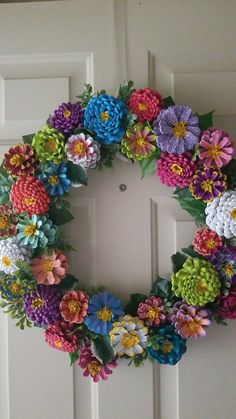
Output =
[{"x1": 137, "y1": 296, "x2": 166, "y2": 326}]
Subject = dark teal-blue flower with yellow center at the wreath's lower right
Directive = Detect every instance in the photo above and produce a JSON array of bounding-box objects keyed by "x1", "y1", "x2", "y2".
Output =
[{"x1": 147, "y1": 325, "x2": 187, "y2": 365}]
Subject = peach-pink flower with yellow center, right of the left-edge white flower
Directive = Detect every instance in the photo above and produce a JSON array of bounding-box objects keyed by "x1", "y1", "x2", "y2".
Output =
[{"x1": 31, "y1": 251, "x2": 68, "y2": 285}]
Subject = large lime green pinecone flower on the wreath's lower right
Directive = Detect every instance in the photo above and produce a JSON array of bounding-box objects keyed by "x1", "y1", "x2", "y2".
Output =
[{"x1": 171, "y1": 258, "x2": 221, "y2": 306}]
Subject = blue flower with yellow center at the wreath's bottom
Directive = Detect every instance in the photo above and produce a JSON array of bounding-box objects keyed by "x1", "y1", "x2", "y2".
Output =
[{"x1": 84, "y1": 292, "x2": 124, "y2": 336}]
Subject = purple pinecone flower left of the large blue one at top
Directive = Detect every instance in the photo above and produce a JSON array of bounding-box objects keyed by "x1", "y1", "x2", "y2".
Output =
[{"x1": 50, "y1": 102, "x2": 83, "y2": 134}]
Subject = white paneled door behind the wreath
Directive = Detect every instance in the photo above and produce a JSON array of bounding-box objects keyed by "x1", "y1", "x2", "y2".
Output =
[{"x1": 0, "y1": 0, "x2": 236, "y2": 419}]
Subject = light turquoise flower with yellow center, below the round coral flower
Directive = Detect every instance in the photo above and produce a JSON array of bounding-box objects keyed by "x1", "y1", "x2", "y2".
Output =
[{"x1": 17, "y1": 214, "x2": 57, "y2": 249}]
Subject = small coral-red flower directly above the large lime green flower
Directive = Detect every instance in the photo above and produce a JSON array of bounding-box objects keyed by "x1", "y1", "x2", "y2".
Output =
[{"x1": 193, "y1": 228, "x2": 222, "y2": 256}]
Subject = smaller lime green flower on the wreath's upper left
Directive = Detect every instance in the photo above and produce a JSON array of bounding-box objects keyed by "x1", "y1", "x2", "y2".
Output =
[{"x1": 32, "y1": 125, "x2": 65, "y2": 164}]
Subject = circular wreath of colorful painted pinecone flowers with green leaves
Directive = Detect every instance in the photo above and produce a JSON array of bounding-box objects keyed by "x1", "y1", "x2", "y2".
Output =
[{"x1": 0, "y1": 81, "x2": 236, "y2": 382}]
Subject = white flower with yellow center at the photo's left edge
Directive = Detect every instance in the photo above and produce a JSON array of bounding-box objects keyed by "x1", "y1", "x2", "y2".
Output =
[{"x1": 0, "y1": 237, "x2": 29, "y2": 275}]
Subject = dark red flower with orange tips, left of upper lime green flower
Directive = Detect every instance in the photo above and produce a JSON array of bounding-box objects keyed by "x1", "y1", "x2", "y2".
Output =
[{"x1": 3, "y1": 144, "x2": 37, "y2": 177}]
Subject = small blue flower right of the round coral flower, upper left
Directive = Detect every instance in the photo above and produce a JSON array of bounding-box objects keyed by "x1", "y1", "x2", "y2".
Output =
[{"x1": 38, "y1": 163, "x2": 71, "y2": 196}]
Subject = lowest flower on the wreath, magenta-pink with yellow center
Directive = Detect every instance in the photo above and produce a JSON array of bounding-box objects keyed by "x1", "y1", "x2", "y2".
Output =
[{"x1": 78, "y1": 344, "x2": 117, "y2": 383}]
